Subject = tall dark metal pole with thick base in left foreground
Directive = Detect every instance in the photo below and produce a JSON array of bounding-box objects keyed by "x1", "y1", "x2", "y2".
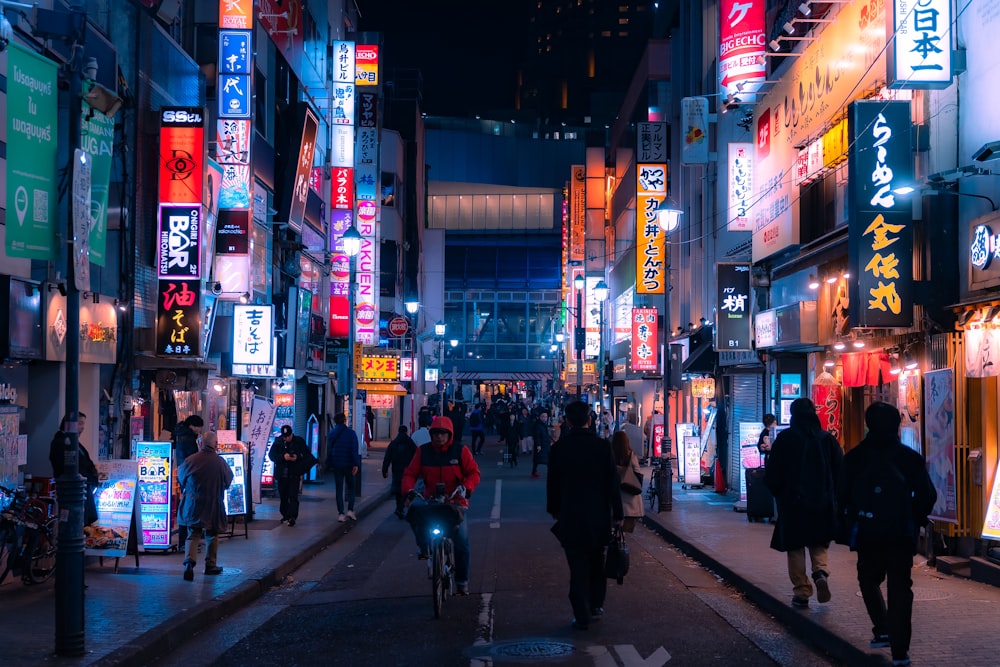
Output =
[{"x1": 55, "y1": 0, "x2": 88, "y2": 656}]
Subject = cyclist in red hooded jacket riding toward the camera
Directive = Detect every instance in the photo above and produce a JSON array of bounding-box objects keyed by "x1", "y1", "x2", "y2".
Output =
[{"x1": 400, "y1": 417, "x2": 480, "y2": 595}]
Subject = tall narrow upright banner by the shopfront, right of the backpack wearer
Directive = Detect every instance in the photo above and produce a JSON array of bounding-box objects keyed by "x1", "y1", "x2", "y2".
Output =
[{"x1": 924, "y1": 368, "x2": 958, "y2": 524}]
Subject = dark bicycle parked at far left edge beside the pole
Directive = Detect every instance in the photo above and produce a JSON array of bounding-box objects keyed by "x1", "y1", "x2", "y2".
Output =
[{"x1": 0, "y1": 487, "x2": 58, "y2": 584}]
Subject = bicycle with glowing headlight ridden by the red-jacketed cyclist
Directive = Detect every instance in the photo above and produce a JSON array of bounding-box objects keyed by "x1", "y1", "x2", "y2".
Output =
[{"x1": 407, "y1": 484, "x2": 465, "y2": 618}]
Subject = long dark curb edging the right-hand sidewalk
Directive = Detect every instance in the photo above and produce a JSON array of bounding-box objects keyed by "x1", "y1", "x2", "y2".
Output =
[{"x1": 642, "y1": 515, "x2": 885, "y2": 665}]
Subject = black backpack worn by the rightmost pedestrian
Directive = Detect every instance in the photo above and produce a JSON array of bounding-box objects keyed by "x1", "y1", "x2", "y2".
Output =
[{"x1": 848, "y1": 452, "x2": 915, "y2": 548}]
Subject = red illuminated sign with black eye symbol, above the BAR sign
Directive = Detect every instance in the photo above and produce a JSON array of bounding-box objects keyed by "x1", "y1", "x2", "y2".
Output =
[{"x1": 160, "y1": 107, "x2": 205, "y2": 204}]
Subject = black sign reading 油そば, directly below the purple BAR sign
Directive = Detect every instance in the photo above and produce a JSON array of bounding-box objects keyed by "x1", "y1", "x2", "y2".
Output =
[{"x1": 156, "y1": 280, "x2": 201, "y2": 357}]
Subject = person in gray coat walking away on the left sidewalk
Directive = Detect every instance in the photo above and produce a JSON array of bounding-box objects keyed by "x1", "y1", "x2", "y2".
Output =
[{"x1": 177, "y1": 431, "x2": 233, "y2": 581}]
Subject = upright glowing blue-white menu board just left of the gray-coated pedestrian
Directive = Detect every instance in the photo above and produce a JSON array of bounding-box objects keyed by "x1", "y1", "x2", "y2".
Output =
[{"x1": 135, "y1": 442, "x2": 173, "y2": 549}]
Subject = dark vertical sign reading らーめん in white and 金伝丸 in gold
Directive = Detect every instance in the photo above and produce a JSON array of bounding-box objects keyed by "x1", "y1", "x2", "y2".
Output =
[{"x1": 848, "y1": 100, "x2": 913, "y2": 327}]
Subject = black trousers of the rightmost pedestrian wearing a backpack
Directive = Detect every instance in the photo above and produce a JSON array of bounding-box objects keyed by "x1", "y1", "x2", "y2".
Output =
[{"x1": 858, "y1": 544, "x2": 913, "y2": 659}]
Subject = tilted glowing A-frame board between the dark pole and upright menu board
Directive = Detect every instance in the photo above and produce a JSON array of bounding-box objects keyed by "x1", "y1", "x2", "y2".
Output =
[{"x1": 83, "y1": 459, "x2": 138, "y2": 558}]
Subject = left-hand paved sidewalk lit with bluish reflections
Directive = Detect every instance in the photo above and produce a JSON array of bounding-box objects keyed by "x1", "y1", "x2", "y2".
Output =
[{"x1": 0, "y1": 442, "x2": 389, "y2": 667}]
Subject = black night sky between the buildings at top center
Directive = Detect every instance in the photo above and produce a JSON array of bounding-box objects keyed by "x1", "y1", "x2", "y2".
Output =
[{"x1": 357, "y1": 0, "x2": 527, "y2": 117}]
